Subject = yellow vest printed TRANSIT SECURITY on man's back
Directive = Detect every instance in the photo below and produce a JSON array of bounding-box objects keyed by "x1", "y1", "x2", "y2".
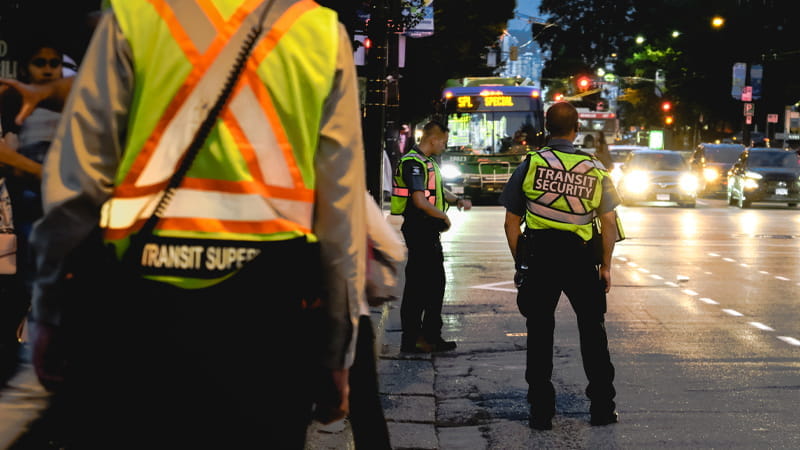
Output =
[{"x1": 522, "y1": 147, "x2": 608, "y2": 241}]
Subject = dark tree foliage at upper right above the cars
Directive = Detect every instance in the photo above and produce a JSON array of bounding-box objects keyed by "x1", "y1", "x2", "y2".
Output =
[{"x1": 539, "y1": 0, "x2": 800, "y2": 141}]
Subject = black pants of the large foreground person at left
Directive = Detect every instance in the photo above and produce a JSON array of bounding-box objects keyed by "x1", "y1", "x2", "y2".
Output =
[{"x1": 48, "y1": 239, "x2": 320, "y2": 450}]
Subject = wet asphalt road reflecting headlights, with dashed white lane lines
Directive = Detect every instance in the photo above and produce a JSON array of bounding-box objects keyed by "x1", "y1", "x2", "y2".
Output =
[{"x1": 330, "y1": 199, "x2": 800, "y2": 449}]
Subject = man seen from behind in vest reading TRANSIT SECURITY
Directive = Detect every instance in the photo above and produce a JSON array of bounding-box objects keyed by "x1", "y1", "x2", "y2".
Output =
[{"x1": 500, "y1": 102, "x2": 621, "y2": 430}]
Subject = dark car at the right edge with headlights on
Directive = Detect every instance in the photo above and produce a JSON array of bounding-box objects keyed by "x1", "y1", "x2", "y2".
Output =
[{"x1": 728, "y1": 148, "x2": 800, "y2": 208}]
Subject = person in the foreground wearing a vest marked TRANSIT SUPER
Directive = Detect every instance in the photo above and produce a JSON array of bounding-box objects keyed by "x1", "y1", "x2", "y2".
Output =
[{"x1": 27, "y1": 0, "x2": 367, "y2": 449}]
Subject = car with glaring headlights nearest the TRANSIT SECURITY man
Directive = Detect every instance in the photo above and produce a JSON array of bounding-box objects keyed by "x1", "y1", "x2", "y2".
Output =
[{"x1": 617, "y1": 150, "x2": 699, "y2": 208}]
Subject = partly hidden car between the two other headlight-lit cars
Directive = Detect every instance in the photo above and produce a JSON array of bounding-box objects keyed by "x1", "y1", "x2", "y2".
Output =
[{"x1": 689, "y1": 143, "x2": 744, "y2": 196}]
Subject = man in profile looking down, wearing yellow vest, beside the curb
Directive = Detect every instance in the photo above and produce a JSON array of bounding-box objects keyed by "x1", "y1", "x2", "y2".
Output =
[{"x1": 392, "y1": 121, "x2": 472, "y2": 352}]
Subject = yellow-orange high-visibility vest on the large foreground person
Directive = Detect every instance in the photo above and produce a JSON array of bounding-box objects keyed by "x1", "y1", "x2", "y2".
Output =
[{"x1": 101, "y1": 0, "x2": 339, "y2": 288}]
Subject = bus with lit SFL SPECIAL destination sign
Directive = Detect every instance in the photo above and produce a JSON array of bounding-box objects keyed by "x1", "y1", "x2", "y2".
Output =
[{"x1": 441, "y1": 85, "x2": 544, "y2": 199}]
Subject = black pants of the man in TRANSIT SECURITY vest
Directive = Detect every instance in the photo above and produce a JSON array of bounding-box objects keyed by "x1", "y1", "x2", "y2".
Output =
[{"x1": 517, "y1": 230, "x2": 616, "y2": 417}]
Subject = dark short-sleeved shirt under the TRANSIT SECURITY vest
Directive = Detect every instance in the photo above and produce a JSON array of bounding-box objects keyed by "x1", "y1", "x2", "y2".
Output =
[{"x1": 500, "y1": 139, "x2": 621, "y2": 217}]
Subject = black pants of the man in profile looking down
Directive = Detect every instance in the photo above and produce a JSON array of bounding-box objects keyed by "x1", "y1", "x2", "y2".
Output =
[{"x1": 400, "y1": 224, "x2": 445, "y2": 345}]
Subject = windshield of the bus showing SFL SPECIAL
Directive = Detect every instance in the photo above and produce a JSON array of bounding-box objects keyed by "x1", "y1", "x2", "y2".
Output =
[{"x1": 447, "y1": 111, "x2": 543, "y2": 155}]
